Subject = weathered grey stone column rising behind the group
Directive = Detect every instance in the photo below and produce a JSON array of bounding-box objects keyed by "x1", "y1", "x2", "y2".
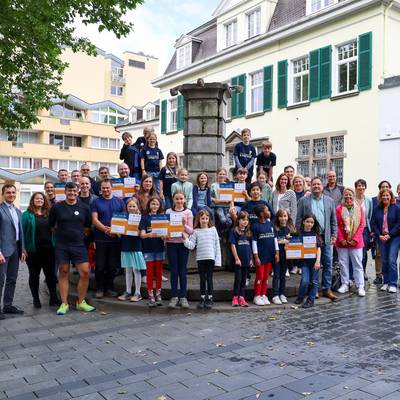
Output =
[{"x1": 171, "y1": 79, "x2": 231, "y2": 181}]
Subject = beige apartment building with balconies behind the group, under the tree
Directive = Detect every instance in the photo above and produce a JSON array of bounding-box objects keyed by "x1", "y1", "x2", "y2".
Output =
[{"x1": 0, "y1": 49, "x2": 158, "y2": 205}]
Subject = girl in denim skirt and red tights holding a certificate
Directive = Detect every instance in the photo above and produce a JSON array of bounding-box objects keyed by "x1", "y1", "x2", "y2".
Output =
[{"x1": 139, "y1": 197, "x2": 165, "y2": 307}]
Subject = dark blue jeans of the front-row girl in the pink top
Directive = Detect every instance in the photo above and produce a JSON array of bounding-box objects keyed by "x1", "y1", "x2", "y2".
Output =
[{"x1": 167, "y1": 243, "x2": 189, "y2": 298}]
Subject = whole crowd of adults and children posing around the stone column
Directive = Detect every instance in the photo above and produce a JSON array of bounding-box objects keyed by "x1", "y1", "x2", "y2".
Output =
[{"x1": 0, "y1": 128, "x2": 400, "y2": 319}]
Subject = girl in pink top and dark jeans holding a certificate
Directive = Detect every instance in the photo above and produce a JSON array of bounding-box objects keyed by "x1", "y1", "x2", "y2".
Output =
[{"x1": 166, "y1": 190, "x2": 193, "y2": 308}]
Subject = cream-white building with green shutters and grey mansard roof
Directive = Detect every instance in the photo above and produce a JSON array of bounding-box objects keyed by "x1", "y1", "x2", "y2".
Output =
[{"x1": 153, "y1": 0, "x2": 400, "y2": 191}]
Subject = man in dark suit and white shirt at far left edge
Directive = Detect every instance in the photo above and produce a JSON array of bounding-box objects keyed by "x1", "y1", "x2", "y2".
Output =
[{"x1": 0, "y1": 183, "x2": 26, "y2": 319}]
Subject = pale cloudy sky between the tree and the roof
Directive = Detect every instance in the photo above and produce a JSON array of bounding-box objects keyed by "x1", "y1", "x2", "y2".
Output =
[{"x1": 76, "y1": 0, "x2": 220, "y2": 74}]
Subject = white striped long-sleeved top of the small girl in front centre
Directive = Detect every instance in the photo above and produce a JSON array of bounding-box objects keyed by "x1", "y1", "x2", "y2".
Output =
[{"x1": 184, "y1": 226, "x2": 221, "y2": 267}]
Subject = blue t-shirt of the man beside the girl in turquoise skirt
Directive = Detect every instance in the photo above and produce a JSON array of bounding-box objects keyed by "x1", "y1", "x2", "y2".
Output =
[{"x1": 90, "y1": 196, "x2": 125, "y2": 242}]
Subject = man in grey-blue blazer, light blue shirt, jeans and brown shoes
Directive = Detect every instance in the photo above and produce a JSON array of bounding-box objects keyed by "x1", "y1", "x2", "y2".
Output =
[{"x1": 296, "y1": 177, "x2": 337, "y2": 301}]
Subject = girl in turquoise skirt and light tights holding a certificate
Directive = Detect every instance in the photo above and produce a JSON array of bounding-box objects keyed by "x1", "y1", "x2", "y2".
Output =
[{"x1": 118, "y1": 198, "x2": 146, "y2": 302}]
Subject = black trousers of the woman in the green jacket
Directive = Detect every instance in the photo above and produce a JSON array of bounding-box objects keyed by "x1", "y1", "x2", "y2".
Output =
[{"x1": 26, "y1": 247, "x2": 57, "y2": 299}]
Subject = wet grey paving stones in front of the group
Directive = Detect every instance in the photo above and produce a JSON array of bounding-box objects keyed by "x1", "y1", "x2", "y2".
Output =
[{"x1": 0, "y1": 264, "x2": 400, "y2": 400}]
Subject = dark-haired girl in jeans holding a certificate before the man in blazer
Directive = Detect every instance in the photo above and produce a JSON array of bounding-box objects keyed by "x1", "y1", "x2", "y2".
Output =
[{"x1": 294, "y1": 214, "x2": 321, "y2": 308}]
